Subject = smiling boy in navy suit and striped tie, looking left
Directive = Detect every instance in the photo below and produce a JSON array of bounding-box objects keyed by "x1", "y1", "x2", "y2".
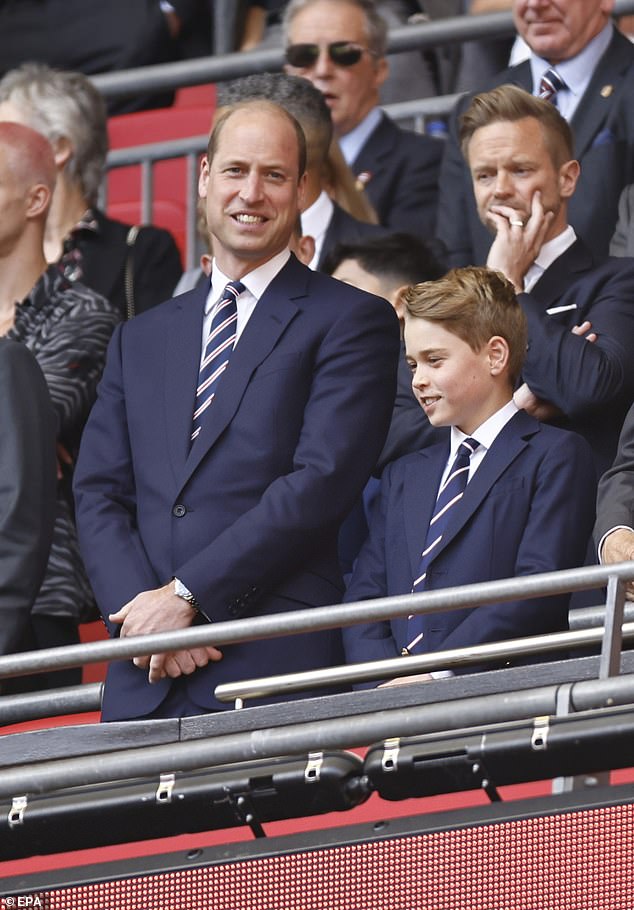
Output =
[{"x1": 344, "y1": 268, "x2": 596, "y2": 682}]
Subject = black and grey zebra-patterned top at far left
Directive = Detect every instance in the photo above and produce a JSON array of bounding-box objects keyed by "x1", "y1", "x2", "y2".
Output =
[{"x1": 7, "y1": 265, "x2": 121, "y2": 619}]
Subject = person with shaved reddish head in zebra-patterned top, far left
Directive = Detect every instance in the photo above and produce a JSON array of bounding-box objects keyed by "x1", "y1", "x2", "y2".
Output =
[{"x1": 0, "y1": 123, "x2": 121, "y2": 692}]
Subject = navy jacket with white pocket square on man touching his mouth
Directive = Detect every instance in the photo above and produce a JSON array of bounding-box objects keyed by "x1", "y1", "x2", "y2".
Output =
[{"x1": 519, "y1": 241, "x2": 634, "y2": 474}]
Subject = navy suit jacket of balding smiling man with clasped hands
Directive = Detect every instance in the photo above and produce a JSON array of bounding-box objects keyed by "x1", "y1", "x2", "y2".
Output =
[{"x1": 75, "y1": 257, "x2": 399, "y2": 719}]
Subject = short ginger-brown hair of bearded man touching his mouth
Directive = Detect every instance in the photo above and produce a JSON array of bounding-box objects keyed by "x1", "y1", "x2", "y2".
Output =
[{"x1": 460, "y1": 85, "x2": 574, "y2": 168}]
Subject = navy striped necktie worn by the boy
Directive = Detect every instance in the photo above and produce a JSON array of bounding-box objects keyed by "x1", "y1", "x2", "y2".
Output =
[{"x1": 402, "y1": 438, "x2": 480, "y2": 654}]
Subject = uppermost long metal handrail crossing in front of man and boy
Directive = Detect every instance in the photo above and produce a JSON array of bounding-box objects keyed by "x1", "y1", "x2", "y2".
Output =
[{"x1": 0, "y1": 561, "x2": 634, "y2": 679}]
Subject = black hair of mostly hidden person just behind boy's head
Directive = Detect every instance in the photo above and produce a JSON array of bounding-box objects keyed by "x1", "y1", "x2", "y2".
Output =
[{"x1": 323, "y1": 232, "x2": 445, "y2": 288}]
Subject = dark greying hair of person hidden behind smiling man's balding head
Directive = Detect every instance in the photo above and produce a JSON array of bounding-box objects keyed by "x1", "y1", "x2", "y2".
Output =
[{"x1": 216, "y1": 73, "x2": 333, "y2": 167}]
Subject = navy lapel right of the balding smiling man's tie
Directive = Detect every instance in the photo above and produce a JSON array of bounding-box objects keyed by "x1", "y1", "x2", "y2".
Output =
[{"x1": 183, "y1": 257, "x2": 310, "y2": 483}]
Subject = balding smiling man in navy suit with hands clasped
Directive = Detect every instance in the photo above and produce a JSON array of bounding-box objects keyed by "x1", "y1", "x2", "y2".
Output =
[{"x1": 75, "y1": 101, "x2": 399, "y2": 720}]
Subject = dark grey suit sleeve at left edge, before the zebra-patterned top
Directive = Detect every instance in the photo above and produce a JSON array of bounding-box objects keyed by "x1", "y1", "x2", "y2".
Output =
[{"x1": 0, "y1": 338, "x2": 57, "y2": 654}]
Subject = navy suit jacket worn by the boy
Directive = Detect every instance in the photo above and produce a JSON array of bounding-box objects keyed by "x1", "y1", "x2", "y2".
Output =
[{"x1": 344, "y1": 411, "x2": 596, "y2": 676}]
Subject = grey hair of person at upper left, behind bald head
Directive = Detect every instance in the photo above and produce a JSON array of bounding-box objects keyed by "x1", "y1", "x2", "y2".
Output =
[{"x1": 0, "y1": 63, "x2": 108, "y2": 205}]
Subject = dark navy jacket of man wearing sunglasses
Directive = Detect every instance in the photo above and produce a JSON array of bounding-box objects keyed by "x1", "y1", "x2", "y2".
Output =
[{"x1": 351, "y1": 114, "x2": 444, "y2": 240}]
